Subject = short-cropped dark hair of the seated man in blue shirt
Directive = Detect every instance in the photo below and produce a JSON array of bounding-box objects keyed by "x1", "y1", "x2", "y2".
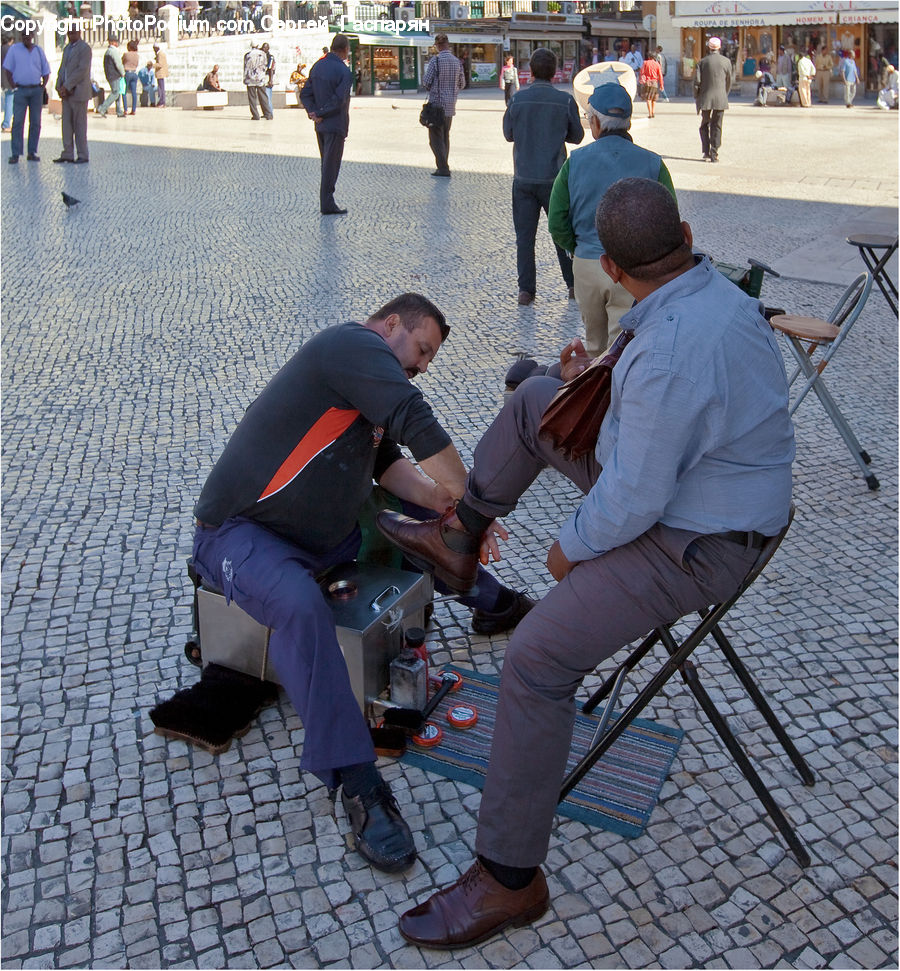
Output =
[{"x1": 597, "y1": 178, "x2": 690, "y2": 280}]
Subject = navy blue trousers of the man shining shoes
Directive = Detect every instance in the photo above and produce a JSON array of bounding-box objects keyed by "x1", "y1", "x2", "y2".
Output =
[{"x1": 193, "y1": 518, "x2": 375, "y2": 788}]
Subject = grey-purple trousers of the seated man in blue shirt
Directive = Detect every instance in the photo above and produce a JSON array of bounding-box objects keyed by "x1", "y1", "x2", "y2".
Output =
[{"x1": 465, "y1": 377, "x2": 757, "y2": 867}]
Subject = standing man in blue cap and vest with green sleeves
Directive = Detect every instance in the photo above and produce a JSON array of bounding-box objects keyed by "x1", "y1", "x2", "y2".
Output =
[{"x1": 548, "y1": 81, "x2": 675, "y2": 357}]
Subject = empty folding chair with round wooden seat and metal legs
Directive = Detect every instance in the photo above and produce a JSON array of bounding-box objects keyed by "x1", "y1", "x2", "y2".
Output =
[{"x1": 769, "y1": 273, "x2": 879, "y2": 489}]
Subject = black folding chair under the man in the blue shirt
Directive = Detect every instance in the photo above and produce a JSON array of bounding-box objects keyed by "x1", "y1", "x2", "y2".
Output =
[{"x1": 559, "y1": 506, "x2": 815, "y2": 867}]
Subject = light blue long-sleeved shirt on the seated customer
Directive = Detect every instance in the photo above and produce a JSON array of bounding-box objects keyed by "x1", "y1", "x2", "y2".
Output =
[{"x1": 559, "y1": 257, "x2": 794, "y2": 562}]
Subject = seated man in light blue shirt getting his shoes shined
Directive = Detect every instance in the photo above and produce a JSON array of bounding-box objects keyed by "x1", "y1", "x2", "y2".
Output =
[{"x1": 377, "y1": 178, "x2": 794, "y2": 948}]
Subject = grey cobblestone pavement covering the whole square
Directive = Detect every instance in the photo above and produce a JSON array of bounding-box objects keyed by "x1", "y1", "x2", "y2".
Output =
[{"x1": 0, "y1": 92, "x2": 897, "y2": 968}]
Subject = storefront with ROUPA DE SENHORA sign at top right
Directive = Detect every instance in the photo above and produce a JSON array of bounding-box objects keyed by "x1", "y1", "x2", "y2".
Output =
[{"x1": 672, "y1": 0, "x2": 897, "y2": 91}]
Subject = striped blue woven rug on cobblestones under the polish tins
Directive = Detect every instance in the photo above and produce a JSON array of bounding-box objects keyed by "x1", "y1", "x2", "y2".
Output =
[{"x1": 403, "y1": 666, "x2": 684, "y2": 837}]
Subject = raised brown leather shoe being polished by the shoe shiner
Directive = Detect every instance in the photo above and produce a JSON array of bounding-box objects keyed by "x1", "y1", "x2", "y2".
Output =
[{"x1": 375, "y1": 509, "x2": 481, "y2": 593}]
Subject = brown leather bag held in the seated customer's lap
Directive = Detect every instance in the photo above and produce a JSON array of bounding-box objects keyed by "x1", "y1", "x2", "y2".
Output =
[{"x1": 538, "y1": 330, "x2": 634, "y2": 461}]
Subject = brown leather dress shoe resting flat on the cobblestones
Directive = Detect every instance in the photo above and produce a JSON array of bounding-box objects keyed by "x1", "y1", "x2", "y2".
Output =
[{"x1": 400, "y1": 860, "x2": 550, "y2": 950}]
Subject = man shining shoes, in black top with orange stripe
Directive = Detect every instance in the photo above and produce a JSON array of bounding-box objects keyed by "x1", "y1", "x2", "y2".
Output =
[{"x1": 179, "y1": 293, "x2": 532, "y2": 871}]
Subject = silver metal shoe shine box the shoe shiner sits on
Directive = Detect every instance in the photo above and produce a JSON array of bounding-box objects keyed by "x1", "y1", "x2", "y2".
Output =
[{"x1": 197, "y1": 563, "x2": 433, "y2": 714}]
